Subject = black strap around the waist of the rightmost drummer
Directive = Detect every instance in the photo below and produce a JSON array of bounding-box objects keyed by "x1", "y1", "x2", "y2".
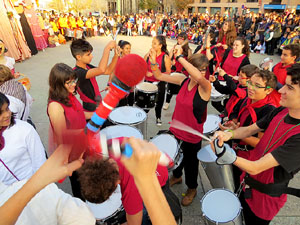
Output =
[{"x1": 245, "y1": 174, "x2": 300, "y2": 198}]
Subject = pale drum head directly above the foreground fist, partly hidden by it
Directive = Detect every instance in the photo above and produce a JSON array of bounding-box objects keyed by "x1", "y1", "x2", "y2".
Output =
[{"x1": 100, "y1": 125, "x2": 144, "y2": 140}]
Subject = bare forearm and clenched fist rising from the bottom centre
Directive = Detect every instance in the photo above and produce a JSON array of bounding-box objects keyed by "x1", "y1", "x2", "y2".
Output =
[{"x1": 122, "y1": 138, "x2": 176, "y2": 225}]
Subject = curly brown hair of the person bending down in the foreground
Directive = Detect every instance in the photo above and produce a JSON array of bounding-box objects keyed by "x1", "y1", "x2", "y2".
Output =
[{"x1": 78, "y1": 158, "x2": 119, "y2": 203}]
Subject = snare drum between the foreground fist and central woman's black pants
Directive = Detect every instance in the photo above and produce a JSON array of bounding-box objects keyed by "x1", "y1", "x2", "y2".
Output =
[{"x1": 150, "y1": 134, "x2": 183, "y2": 170}]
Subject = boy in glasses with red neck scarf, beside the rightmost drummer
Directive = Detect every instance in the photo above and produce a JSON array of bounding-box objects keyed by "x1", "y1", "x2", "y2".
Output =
[{"x1": 220, "y1": 70, "x2": 277, "y2": 188}]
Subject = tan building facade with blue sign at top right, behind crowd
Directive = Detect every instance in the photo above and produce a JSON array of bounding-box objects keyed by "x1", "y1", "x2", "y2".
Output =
[{"x1": 187, "y1": 0, "x2": 300, "y2": 15}]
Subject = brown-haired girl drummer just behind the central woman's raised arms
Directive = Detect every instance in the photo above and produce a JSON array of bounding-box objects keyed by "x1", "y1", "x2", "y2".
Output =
[{"x1": 163, "y1": 32, "x2": 192, "y2": 110}]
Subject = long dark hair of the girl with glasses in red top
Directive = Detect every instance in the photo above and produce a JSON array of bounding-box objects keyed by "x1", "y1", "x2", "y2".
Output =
[{"x1": 48, "y1": 63, "x2": 77, "y2": 106}]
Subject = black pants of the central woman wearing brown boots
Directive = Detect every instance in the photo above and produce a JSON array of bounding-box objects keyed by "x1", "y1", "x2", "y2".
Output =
[{"x1": 173, "y1": 139, "x2": 202, "y2": 189}]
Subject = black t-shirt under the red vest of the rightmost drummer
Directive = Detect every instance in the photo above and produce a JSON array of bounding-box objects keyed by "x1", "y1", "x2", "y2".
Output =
[{"x1": 256, "y1": 107, "x2": 300, "y2": 183}]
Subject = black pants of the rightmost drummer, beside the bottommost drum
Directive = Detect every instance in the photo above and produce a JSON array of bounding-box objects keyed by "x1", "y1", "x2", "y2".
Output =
[{"x1": 239, "y1": 192, "x2": 271, "y2": 225}]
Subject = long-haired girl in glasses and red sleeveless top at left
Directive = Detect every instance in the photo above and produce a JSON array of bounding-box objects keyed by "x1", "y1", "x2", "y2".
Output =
[{"x1": 47, "y1": 63, "x2": 93, "y2": 199}]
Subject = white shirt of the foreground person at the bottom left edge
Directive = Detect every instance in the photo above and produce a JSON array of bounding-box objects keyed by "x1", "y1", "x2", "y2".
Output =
[{"x1": 0, "y1": 180, "x2": 96, "y2": 225}]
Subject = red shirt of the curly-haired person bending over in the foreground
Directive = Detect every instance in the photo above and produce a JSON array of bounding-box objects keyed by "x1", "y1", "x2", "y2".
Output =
[{"x1": 116, "y1": 160, "x2": 168, "y2": 215}]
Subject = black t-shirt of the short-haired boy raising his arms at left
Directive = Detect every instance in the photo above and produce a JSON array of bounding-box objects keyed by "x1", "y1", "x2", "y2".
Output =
[{"x1": 74, "y1": 64, "x2": 95, "y2": 101}]
